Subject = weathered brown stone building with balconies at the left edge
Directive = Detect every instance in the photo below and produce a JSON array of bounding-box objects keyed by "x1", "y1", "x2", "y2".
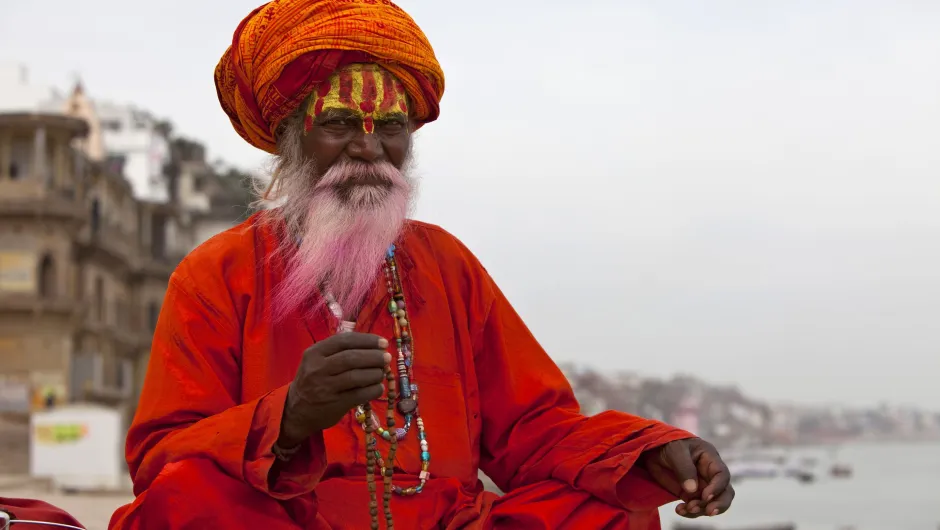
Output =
[{"x1": 0, "y1": 104, "x2": 188, "y2": 472}]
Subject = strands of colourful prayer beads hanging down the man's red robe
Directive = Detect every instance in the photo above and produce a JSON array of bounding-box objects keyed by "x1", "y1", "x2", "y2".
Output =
[{"x1": 326, "y1": 245, "x2": 431, "y2": 530}]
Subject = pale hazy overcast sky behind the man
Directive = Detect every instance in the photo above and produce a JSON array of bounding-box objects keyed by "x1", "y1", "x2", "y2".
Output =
[{"x1": 0, "y1": 0, "x2": 940, "y2": 408}]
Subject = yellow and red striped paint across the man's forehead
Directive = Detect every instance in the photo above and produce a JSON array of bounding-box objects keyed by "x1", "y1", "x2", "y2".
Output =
[{"x1": 304, "y1": 64, "x2": 408, "y2": 134}]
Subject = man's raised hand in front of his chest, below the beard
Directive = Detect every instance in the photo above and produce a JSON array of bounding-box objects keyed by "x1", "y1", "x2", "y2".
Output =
[{"x1": 278, "y1": 332, "x2": 392, "y2": 449}]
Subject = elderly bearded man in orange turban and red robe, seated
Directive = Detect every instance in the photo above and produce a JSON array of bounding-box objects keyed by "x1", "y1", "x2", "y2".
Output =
[{"x1": 111, "y1": 0, "x2": 734, "y2": 530}]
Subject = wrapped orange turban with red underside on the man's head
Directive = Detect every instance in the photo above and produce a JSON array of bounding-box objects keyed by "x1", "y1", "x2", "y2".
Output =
[{"x1": 215, "y1": 0, "x2": 444, "y2": 153}]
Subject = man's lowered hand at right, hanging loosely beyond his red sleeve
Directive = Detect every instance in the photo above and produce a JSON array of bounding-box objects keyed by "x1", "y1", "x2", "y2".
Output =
[{"x1": 641, "y1": 438, "x2": 734, "y2": 519}]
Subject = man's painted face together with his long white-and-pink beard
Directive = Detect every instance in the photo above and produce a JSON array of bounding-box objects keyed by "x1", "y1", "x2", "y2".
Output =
[{"x1": 274, "y1": 65, "x2": 415, "y2": 316}]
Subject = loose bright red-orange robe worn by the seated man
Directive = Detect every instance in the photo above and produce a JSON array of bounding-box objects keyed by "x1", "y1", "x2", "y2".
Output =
[{"x1": 110, "y1": 218, "x2": 691, "y2": 530}]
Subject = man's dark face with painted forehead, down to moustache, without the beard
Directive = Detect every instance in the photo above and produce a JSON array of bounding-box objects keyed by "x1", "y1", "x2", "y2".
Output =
[{"x1": 303, "y1": 64, "x2": 411, "y2": 184}]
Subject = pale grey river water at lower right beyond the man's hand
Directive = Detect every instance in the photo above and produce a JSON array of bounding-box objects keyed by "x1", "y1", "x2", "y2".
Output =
[{"x1": 661, "y1": 442, "x2": 940, "y2": 530}]
